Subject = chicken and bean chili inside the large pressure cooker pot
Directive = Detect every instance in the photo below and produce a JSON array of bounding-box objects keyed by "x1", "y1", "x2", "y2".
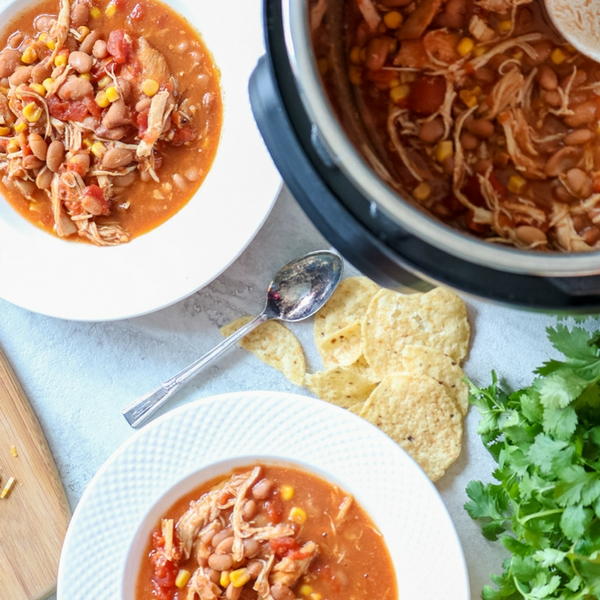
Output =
[{"x1": 310, "y1": 0, "x2": 600, "y2": 252}]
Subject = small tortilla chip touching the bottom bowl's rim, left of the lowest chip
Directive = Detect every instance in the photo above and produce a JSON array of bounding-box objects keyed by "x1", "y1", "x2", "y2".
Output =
[{"x1": 304, "y1": 367, "x2": 377, "y2": 408}]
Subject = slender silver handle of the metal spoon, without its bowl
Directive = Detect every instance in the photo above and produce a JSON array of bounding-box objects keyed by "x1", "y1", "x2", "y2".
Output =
[{"x1": 122, "y1": 311, "x2": 272, "y2": 428}]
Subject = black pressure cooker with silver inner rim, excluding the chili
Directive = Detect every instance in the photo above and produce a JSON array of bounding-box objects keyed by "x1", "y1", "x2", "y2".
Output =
[{"x1": 250, "y1": 0, "x2": 600, "y2": 311}]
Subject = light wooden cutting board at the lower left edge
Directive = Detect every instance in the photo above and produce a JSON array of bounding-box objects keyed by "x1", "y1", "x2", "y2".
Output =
[{"x1": 0, "y1": 350, "x2": 70, "y2": 600}]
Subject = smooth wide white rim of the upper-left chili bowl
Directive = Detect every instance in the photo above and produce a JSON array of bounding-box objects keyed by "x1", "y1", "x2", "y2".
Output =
[{"x1": 0, "y1": 0, "x2": 280, "y2": 321}]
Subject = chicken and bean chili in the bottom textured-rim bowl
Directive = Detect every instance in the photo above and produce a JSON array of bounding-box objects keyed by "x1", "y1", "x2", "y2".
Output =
[{"x1": 136, "y1": 465, "x2": 398, "y2": 600}]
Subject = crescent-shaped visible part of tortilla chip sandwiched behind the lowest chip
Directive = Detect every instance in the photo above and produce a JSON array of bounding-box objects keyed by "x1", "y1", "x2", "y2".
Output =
[{"x1": 400, "y1": 346, "x2": 469, "y2": 416}]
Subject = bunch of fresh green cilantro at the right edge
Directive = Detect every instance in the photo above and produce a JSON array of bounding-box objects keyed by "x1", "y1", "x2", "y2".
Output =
[{"x1": 465, "y1": 322, "x2": 600, "y2": 600}]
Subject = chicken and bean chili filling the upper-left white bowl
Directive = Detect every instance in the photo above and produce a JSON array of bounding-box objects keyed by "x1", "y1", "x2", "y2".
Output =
[{"x1": 0, "y1": 0, "x2": 222, "y2": 246}]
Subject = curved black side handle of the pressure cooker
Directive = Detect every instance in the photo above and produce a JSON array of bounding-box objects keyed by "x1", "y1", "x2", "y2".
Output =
[{"x1": 249, "y1": 56, "x2": 433, "y2": 291}]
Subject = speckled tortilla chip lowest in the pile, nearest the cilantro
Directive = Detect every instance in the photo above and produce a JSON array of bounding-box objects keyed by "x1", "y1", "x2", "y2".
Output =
[{"x1": 359, "y1": 374, "x2": 463, "y2": 481}]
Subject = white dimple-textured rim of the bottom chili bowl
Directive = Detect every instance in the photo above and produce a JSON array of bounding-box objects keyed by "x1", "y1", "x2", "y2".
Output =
[{"x1": 58, "y1": 392, "x2": 470, "y2": 600}]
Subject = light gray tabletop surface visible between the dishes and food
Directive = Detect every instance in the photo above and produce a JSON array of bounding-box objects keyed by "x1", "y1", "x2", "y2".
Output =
[{"x1": 0, "y1": 193, "x2": 564, "y2": 600}]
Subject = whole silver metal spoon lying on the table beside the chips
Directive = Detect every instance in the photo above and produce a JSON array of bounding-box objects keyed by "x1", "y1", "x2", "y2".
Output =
[{"x1": 122, "y1": 251, "x2": 343, "y2": 427}]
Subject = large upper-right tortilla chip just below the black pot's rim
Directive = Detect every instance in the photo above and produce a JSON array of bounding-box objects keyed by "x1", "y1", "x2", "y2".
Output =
[{"x1": 362, "y1": 288, "x2": 470, "y2": 378}]
